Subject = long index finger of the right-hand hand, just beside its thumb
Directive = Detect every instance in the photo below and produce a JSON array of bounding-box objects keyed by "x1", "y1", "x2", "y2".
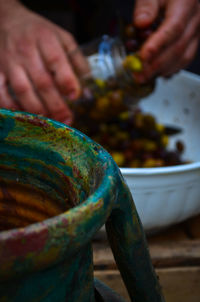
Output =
[{"x1": 141, "y1": 0, "x2": 198, "y2": 61}]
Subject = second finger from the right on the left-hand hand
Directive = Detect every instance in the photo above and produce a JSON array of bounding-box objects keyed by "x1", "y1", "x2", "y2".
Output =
[{"x1": 39, "y1": 32, "x2": 80, "y2": 100}]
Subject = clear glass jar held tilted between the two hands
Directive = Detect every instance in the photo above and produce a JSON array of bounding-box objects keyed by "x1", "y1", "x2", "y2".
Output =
[{"x1": 79, "y1": 35, "x2": 155, "y2": 107}]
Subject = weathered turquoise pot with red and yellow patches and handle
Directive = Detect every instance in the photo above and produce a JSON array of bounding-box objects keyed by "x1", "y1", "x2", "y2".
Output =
[{"x1": 0, "y1": 110, "x2": 163, "y2": 302}]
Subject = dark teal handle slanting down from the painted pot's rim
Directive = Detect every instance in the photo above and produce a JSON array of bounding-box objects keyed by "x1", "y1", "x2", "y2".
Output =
[{"x1": 106, "y1": 181, "x2": 164, "y2": 302}]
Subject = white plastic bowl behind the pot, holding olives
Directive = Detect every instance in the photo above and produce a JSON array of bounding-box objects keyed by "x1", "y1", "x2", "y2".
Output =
[{"x1": 121, "y1": 71, "x2": 200, "y2": 231}]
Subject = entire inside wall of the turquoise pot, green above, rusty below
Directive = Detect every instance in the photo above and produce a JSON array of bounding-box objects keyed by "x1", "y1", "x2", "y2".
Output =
[{"x1": 0, "y1": 111, "x2": 103, "y2": 231}]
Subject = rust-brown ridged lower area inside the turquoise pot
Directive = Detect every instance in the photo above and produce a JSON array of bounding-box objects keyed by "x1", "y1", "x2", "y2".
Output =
[{"x1": 0, "y1": 182, "x2": 71, "y2": 231}]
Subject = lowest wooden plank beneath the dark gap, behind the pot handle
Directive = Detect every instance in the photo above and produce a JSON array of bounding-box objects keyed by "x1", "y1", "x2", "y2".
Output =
[{"x1": 95, "y1": 267, "x2": 200, "y2": 302}]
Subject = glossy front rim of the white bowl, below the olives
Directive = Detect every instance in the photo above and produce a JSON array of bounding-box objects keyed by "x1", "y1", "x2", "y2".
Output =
[{"x1": 120, "y1": 161, "x2": 200, "y2": 175}]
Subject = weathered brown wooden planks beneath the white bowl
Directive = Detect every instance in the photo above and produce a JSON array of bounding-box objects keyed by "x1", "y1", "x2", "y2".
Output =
[{"x1": 93, "y1": 215, "x2": 200, "y2": 302}]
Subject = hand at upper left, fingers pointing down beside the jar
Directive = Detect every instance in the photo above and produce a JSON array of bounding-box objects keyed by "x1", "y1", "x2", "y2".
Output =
[{"x1": 0, "y1": 1, "x2": 88, "y2": 124}]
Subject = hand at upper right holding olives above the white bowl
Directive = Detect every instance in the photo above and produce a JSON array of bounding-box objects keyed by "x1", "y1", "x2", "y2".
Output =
[{"x1": 133, "y1": 0, "x2": 200, "y2": 82}]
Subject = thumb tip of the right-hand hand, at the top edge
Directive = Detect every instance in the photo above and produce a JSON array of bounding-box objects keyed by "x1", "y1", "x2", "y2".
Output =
[{"x1": 133, "y1": 0, "x2": 160, "y2": 28}]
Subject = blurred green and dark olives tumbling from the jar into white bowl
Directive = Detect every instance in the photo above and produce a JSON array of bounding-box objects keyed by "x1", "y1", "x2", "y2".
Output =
[{"x1": 71, "y1": 21, "x2": 184, "y2": 168}]
